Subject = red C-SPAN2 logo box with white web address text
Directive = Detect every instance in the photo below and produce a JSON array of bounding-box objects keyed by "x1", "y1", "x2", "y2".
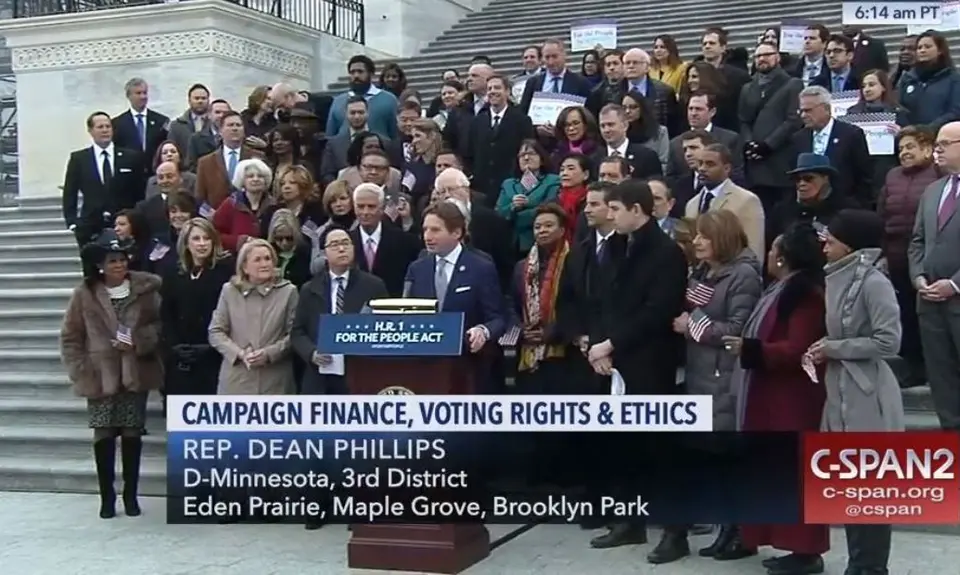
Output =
[{"x1": 801, "y1": 432, "x2": 960, "y2": 525}]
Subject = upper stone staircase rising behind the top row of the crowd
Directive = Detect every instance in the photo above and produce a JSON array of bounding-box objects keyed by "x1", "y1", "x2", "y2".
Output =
[{"x1": 330, "y1": 0, "x2": 944, "y2": 98}]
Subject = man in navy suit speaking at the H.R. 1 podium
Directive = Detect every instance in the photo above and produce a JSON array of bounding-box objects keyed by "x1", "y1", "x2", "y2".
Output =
[{"x1": 404, "y1": 202, "x2": 507, "y2": 353}]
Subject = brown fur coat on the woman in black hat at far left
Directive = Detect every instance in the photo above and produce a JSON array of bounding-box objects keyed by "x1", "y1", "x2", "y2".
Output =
[{"x1": 60, "y1": 271, "x2": 163, "y2": 399}]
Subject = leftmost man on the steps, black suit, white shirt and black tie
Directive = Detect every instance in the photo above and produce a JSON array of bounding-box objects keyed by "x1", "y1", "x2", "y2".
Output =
[{"x1": 63, "y1": 112, "x2": 145, "y2": 247}]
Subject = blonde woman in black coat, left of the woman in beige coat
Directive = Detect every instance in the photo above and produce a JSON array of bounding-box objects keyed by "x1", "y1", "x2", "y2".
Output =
[{"x1": 160, "y1": 218, "x2": 235, "y2": 402}]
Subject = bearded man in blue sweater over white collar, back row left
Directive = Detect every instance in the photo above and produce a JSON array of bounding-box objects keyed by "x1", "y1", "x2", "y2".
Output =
[{"x1": 326, "y1": 55, "x2": 398, "y2": 140}]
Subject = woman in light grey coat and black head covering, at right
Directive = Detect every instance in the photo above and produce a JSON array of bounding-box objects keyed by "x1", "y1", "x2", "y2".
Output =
[{"x1": 807, "y1": 210, "x2": 904, "y2": 575}]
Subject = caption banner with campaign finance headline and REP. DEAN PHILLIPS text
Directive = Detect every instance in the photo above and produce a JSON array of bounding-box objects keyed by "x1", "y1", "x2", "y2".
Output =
[{"x1": 167, "y1": 396, "x2": 801, "y2": 524}]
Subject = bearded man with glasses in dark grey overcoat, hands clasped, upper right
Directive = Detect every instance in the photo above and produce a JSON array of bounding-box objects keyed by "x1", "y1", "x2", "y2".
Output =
[{"x1": 740, "y1": 42, "x2": 803, "y2": 213}]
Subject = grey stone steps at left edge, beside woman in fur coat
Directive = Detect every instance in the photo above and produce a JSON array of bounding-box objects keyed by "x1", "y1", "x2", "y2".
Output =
[{"x1": 0, "y1": 200, "x2": 166, "y2": 495}]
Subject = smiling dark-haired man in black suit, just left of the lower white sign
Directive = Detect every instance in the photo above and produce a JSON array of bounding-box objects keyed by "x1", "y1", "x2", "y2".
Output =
[{"x1": 463, "y1": 75, "x2": 534, "y2": 207}]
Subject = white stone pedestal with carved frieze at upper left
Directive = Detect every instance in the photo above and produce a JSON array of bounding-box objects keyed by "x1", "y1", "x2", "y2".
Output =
[{"x1": 0, "y1": 0, "x2": 330, "y2": 198}]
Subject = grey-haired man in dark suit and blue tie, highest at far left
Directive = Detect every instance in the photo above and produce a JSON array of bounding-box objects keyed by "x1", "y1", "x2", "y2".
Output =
[{"x1": 112, "y1": 78, "x2": 170, "y2": 174}]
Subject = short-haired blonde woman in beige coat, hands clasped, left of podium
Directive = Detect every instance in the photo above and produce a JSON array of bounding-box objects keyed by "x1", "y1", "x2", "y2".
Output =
[{"x1": 209, "y1": 239, "x2": 298, "y2": 395}]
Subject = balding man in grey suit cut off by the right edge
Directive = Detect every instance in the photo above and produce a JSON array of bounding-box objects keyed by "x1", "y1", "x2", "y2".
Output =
[{"x1": 908, "y1": 122, "x2": 960, "y2": 431}]
